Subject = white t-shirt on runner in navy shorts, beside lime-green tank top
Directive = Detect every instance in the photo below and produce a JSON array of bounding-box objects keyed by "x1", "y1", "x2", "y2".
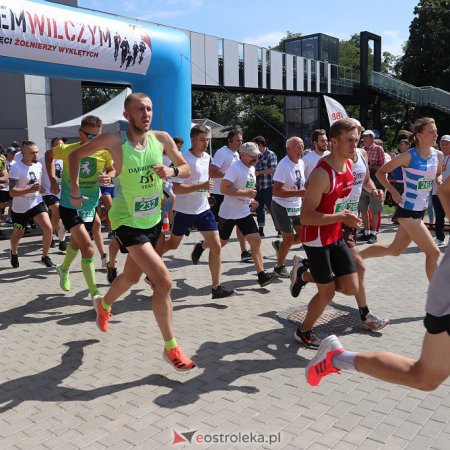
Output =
[{"x1": 173, "y1": 150, "x2": 211, "y2": 214}]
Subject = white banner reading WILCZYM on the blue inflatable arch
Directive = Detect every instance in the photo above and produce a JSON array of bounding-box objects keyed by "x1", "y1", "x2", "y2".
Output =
[{"x1": 0, "y1": 0, "x2": 152, "y2": 75}]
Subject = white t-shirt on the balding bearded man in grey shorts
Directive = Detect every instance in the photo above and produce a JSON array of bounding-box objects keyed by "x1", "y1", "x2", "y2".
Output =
[{"x1": 272, "y1": 155, "x2": 305, "y2": 214}]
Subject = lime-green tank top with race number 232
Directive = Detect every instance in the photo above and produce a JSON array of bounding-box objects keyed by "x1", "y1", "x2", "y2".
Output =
[{"x1": 109, "y1": 133, "x2": 163, "y2": 230}]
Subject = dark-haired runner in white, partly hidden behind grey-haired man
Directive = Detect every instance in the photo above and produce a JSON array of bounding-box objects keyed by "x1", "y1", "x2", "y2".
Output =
[{"x1": 209, "y1": 128, "x2": 252, "y2": 262}]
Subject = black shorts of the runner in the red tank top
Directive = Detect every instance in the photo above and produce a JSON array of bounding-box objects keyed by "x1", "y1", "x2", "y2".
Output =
[{"x1": 303, "y1": 238, "x2": 356, "y2": 284}]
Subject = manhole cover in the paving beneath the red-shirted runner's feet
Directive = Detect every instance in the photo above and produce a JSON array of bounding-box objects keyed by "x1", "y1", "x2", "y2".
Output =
[{"x1": 287, "y1": 303, "x2": 361, "y2": 335}]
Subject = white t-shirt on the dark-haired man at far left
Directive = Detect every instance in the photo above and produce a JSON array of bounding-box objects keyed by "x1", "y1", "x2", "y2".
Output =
[{"x1": 9, "y1": 161, "x2": 42, "y2": 213}]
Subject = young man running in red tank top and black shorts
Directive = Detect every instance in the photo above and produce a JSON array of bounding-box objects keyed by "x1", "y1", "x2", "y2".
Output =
[{"x1": 294, "y1": 119, "x2": 361, "y2": 349}]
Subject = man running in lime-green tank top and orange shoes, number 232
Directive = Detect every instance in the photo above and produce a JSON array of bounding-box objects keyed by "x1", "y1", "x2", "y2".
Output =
[{"x1": 69, "y1": 93, "x2": 196, "y2": 371}]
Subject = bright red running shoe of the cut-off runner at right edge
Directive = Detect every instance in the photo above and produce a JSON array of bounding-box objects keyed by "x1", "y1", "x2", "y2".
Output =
[{"x1": 305, "y1": 334, "x2": 345, "y2": 386}]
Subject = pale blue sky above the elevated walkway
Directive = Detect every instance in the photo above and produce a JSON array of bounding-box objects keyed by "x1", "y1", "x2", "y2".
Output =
[{"x1": 78, "y1": 0, "x2": 419, "y2": 56}]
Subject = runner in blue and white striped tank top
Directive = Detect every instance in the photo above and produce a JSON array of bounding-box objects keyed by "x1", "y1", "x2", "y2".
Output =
[{"x1": 360, "y1": 117, "x2": 443, "y2": 280}]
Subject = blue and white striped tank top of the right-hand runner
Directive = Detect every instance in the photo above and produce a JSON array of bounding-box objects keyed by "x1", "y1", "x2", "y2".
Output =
[{"x1": 401, "y1": 148, "x2": 439, "y2": 211}]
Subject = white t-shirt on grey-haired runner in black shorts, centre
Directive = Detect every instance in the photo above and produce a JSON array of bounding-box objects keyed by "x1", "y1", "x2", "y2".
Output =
[{"x1": 219, "y1": 160, "x2": 256, "y2": 219}]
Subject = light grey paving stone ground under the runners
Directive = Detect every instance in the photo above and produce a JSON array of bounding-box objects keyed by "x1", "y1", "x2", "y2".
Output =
[{"x1": 0, "y1": 220, "x2": 450, "y2": 450}]
